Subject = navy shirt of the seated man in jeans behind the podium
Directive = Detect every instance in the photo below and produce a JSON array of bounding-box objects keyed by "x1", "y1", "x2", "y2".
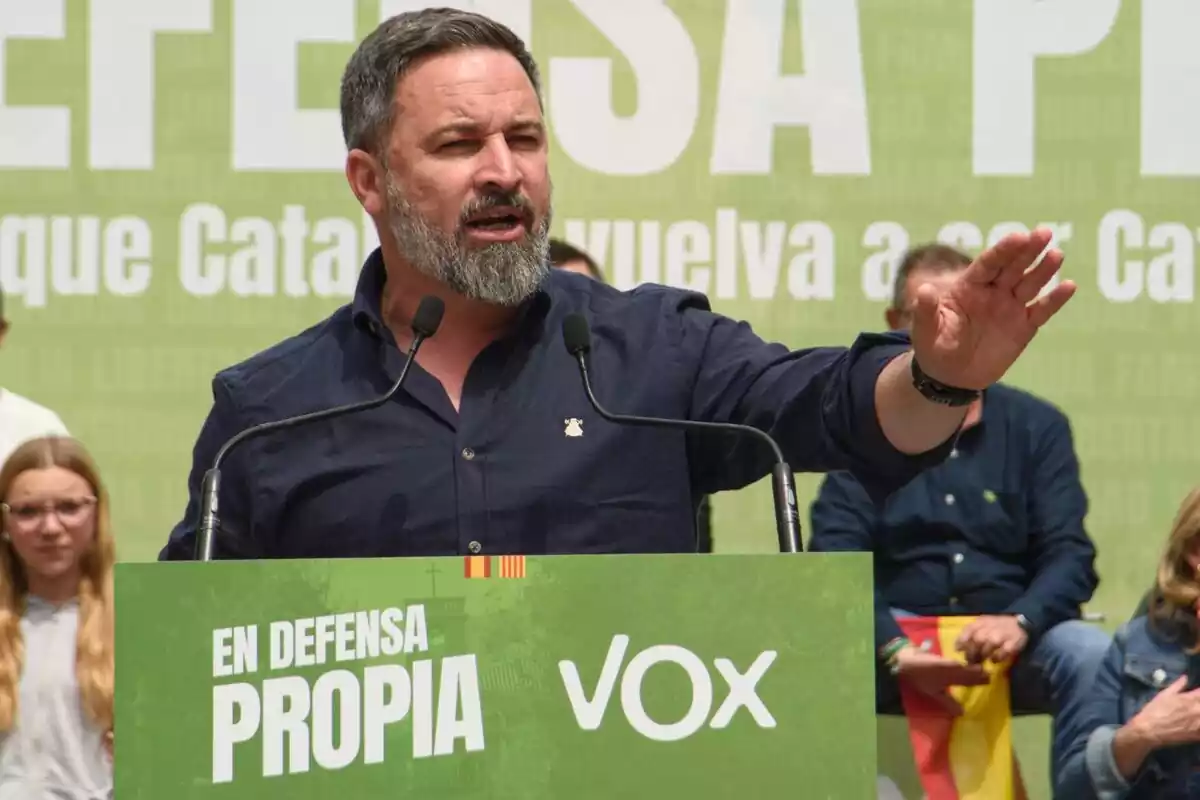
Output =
[{"x1": 809, "y1": 385, "x2": 1099, "y2": 646}]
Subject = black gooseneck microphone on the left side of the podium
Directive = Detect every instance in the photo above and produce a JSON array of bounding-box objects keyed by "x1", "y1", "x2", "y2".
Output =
[{"x1": 194, "y1": 295, "x2": 445, "y2": 561}]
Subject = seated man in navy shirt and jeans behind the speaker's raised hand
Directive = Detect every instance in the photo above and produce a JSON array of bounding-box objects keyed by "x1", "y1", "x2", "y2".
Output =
[{"x1": 810, "y1": 245, "x2": 1110, "y2": 786}]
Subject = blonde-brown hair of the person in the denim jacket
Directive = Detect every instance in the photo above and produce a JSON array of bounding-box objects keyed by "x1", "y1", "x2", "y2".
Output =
[{"x1": 1148, "y1": 488, "x2": 1200, "y2": 652}]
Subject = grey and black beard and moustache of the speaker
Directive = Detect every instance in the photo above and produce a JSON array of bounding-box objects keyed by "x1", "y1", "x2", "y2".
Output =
[{"x1": 388, "y1": 174, "x2": 551, "y2": 306}]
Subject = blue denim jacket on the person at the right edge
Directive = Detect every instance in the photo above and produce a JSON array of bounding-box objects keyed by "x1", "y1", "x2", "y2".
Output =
[{"x1": 1055, "y1": 616, "x2": 1200, "y2": 800}]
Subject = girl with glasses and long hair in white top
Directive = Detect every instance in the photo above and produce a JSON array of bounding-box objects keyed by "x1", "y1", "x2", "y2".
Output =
[{"x1": 0, "y1": 437, "x2": 116, "y2": 800}]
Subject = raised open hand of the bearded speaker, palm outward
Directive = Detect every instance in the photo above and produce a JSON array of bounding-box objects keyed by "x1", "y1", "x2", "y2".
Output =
[{"x1": 911, "y1": 228, "x2": 1075, "y2": 390}]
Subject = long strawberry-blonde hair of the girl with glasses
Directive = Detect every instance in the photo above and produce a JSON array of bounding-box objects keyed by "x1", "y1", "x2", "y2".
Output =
[{"x1": 0, "y1": 437, "x2": 116, "y2": 732}]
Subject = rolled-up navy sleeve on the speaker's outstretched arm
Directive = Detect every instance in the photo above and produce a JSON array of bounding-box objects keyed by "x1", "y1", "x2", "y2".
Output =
[{"x1": 677, "y1": 294, "x2": 952, "y2": 503}]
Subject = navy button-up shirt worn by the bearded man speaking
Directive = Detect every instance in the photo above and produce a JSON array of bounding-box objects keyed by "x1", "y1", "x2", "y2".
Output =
[{"x1": 160, "y1": 251, "x2": 949, "y2": 559}]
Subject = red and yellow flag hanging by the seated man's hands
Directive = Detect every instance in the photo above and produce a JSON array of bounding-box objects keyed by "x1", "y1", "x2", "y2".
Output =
[{"x1": 898, "y1": 616, "x2": 1026, "y2": 800}]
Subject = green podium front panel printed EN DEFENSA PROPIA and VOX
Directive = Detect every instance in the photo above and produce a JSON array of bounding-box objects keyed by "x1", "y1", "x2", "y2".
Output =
[{"x1": 115, "y1": 554, "x2": 876, "y2": 800}]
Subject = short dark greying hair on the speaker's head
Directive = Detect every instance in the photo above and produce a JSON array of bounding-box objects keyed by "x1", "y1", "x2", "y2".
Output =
[{"x1": 341, "y1": 8, "x2": 541, "y2": 160}]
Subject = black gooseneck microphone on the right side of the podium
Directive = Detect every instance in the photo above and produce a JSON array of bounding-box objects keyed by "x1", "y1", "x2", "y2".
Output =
[{"x1": 563, "y1": 313, "x2": 803, "y2": 553}]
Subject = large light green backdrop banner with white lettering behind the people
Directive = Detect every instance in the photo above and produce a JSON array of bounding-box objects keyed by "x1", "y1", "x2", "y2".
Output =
[{"x1": 0, "y1": 0, "x2": 1200, "y2": 604}]
